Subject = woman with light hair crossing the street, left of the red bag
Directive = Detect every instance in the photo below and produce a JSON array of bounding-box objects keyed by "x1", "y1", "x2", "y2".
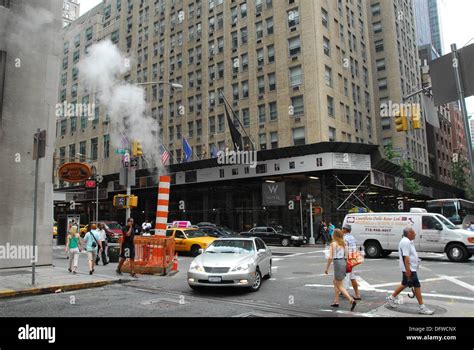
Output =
[{"x1": 324, "y1": 229, "x2": 357, "y2": 311}]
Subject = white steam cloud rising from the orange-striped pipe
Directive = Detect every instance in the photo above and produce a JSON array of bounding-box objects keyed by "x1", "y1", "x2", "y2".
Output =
[{"x1": 78, "y1": 40, "x2": 165, "y2": 173}]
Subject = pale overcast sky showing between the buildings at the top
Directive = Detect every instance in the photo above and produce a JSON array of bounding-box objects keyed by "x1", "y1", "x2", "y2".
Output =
[{"x1": 80, "y1": 0, "x2": 474, "y2": 114}]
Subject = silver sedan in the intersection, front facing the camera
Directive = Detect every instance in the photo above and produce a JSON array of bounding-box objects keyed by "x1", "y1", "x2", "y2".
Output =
[{"x1": 188, "y1": 237, "x2": 272, "y2": 292}]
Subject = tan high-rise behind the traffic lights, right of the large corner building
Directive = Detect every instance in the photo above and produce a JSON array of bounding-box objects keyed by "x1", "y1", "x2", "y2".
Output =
[{"x1": 370, "y1": 0, "x2": 430, "y2": 176}]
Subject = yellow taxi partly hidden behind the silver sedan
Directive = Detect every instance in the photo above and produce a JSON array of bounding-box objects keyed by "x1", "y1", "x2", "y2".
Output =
[{"x1": 166, "y1": 227, "x2": 216, "y2": 256}]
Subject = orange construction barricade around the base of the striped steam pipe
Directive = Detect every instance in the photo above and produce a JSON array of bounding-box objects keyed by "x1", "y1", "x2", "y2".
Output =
[{"x1": 122, "y1": 236, "x2": 175, "y2": 276}]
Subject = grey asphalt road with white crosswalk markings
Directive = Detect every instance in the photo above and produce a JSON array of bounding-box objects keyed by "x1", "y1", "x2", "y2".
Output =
[{"x1": 0, "y1": 247, "x2": 474, "y2": 317}]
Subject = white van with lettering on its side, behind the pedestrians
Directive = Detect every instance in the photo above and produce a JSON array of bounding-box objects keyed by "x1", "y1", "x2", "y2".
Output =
[{"x1": 344, "y1": 212, "x2": 474, "y2": 262}]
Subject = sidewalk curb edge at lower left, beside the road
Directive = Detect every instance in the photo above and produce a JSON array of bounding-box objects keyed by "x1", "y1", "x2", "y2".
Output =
[{"x1": 0, "y1": 279, "x2": 128, "y2": 300}]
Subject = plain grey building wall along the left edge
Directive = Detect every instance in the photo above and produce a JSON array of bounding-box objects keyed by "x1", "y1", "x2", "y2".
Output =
[{"x1": 0, "y1": 0, "x2": 61, "y2": 268}]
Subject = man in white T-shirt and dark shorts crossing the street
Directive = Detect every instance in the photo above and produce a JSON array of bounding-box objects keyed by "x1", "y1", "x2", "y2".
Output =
[{"x1": 387, "y1": 227, "x2": 434, "y2": 315}]
